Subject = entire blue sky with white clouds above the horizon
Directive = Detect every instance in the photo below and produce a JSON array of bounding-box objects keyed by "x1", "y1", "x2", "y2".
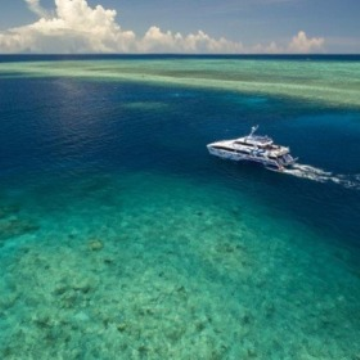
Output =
[{"x1": 0, "y1": 0, "x2": 360, "y2": 54}]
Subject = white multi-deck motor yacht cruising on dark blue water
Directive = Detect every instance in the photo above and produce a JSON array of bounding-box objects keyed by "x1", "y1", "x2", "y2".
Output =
[{"x1": 207, "y1": 126, "x2": 297, "y2": 171}]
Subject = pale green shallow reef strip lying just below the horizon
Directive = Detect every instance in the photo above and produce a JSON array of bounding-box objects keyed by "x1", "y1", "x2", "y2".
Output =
[{"x1": 0, "y1": 59, "x2": 360, "y2": 108}]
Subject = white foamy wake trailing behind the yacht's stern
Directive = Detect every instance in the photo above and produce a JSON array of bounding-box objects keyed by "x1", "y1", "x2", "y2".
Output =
[{"x1": 283, "y1": 164, "x2": 360, "y2": 190}]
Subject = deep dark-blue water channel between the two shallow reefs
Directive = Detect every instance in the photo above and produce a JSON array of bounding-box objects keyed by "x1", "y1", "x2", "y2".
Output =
[{"x1": 0, "y1": 74, "x2": 360, "y2": 246}]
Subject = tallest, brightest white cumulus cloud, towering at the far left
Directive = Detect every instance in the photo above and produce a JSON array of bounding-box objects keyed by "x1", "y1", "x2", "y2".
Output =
[{"x1": 0, "y1": 0, "x2": 135, "y2": 53}]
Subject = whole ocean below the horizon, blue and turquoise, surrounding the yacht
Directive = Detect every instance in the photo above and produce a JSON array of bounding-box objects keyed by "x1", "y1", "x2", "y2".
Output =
[{"x1": 0, "y1": 55, "x2": 360, "y2": 360}]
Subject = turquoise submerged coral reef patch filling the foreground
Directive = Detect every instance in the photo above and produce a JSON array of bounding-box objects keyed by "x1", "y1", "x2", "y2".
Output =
[{"x1": 0, "y1": 173, "x2": 359, "y2": 359}]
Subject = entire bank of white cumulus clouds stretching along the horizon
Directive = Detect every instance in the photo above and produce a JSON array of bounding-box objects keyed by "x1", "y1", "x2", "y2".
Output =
[{"x1": 0, "y1": 0, "x2": 324, "y2": 53}]
